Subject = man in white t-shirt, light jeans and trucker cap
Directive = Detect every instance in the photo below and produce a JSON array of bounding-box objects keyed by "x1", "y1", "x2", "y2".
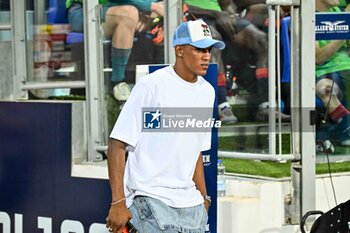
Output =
[{"x1": 106, "y1": 20, "x2": 225, "y2": 233}]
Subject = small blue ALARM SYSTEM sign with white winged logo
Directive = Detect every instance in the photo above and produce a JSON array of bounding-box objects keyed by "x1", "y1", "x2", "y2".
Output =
[{"x1": 315, "y1": 12, "x2": 350, "y2": 40}]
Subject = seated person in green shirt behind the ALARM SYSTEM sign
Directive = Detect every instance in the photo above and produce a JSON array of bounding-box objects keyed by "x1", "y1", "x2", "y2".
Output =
[{"x1": 316, "y1": 0, "x2": 350, "y2": 146}]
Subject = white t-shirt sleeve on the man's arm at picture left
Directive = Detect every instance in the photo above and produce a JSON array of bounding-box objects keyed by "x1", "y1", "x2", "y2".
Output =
[{"x1": 110, "y1": 78, "x2": 154, "y2": 147}]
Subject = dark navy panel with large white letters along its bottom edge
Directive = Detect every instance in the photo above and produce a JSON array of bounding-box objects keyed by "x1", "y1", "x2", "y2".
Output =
[{"x1": 0, "y1": 102, "x2": 111, "y2": 233}]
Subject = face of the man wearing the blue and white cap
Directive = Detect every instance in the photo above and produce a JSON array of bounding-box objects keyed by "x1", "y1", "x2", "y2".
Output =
[{"x1": 181, "y1": 45, "x2": 211, "y2": 76}]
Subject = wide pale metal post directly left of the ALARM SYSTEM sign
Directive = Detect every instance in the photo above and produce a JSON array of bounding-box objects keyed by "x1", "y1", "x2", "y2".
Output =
[{"x1": 299, "y1": 1, "x2": 316, "y2": 218}]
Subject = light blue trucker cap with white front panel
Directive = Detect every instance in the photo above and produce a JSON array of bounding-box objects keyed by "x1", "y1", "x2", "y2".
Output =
[{"x1": 173, "y1": 19, "x2": 225, "y2": 49}]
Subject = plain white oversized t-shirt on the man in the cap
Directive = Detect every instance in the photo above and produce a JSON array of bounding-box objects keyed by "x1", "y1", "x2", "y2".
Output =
[{"x1": 110, "y1": 66, "x2": 215, "y2": 208}]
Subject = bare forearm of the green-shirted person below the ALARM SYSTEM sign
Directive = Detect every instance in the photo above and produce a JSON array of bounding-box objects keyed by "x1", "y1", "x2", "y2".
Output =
[{"x1": 316, "y1": 40, "x2": 345, "y2": 65}]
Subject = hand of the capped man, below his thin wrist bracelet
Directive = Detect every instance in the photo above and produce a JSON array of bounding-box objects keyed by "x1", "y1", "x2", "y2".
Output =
[{"x1": 106, "y1": 202, "x2": 132, "y2": 233}]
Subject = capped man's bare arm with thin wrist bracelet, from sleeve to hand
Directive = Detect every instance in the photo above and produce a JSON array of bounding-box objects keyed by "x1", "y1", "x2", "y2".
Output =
[{"x1": 106, "y1": 139, "x2": 132, "y2": 232}]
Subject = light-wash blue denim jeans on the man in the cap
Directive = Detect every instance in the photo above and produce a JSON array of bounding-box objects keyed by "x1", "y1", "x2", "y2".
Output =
[{"x1": 130, "y1": 196, "x2": 208, "y2": 233}]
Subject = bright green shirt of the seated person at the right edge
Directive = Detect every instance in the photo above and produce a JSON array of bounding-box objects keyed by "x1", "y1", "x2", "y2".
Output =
[{"x1": 316, "y1": 7, "x2": 350, "y2": 77}]
